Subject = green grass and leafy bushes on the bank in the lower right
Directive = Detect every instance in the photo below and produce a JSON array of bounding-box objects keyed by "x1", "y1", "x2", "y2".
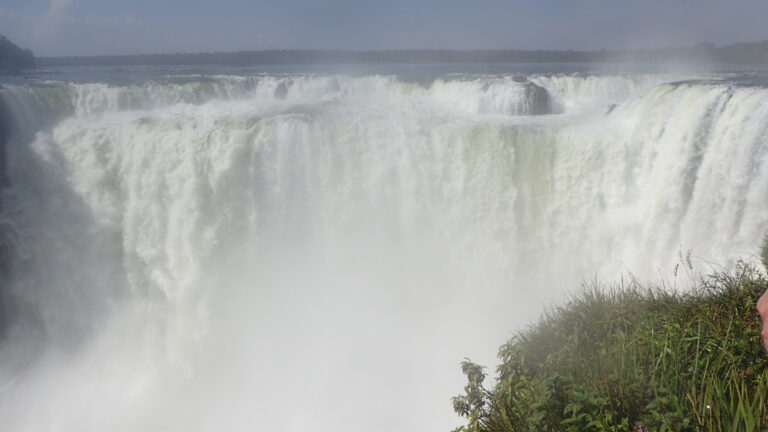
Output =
[{"x1": 453, "y1": 265, "x2": 768, "y2": 432}]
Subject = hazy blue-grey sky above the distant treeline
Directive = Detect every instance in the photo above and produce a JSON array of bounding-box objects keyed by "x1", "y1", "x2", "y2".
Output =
[{"x1": 0, "y1": 0, "x2": 768, "y2": 56}]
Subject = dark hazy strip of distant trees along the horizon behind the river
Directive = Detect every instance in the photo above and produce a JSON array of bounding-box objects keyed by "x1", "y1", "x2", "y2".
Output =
[{"x1": 0, "y1": 36, "x2": 768, "y2": 69}]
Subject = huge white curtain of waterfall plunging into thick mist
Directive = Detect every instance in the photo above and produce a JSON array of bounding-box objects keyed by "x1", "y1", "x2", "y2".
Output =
[{"x1": 0, "y1": 74, "x2": 768, "y2": 432}]
